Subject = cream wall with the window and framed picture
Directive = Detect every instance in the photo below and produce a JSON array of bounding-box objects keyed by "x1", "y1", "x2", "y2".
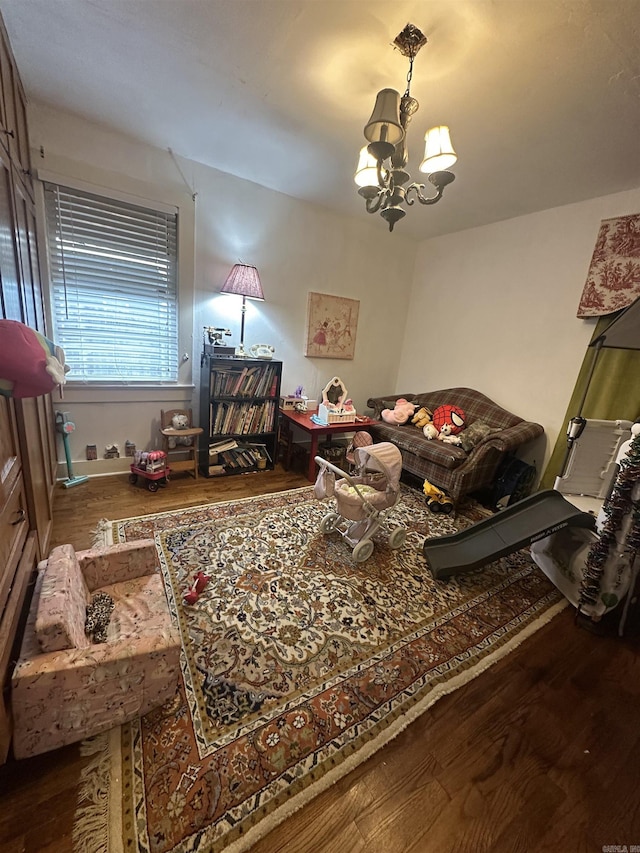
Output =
[{"x1": 29, "y1": 105, "x2": 416, "y2": 476}]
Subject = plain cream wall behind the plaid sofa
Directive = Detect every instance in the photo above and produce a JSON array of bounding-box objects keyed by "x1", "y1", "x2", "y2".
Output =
[{"x1": 396, "y1": 189, "x2": 640, "y2": 473}]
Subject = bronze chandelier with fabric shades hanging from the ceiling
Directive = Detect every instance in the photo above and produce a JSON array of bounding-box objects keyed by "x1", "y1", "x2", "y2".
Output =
[{"x1": 354, "y1": 24, "x2": 458, "y2": 231}]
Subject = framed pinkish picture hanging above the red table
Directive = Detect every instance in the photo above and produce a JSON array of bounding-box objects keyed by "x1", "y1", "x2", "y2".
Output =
[{"x1": 304, "y1": 292, "x2": 360, "y2": 358}]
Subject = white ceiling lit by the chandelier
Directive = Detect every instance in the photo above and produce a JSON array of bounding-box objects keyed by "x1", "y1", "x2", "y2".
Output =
[{"x1": 0, "y1": 0, "x2": 640, "y2": 238}]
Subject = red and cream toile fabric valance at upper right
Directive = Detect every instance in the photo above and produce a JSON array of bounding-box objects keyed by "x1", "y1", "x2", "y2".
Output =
[{"x1": 577, "y1": 213, "x2": 640, "y2": 318}]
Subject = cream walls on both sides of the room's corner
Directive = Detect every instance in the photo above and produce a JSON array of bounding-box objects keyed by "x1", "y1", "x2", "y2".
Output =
[{"x1": 29, "y1": 105, "x2": 640, "y2": 476}]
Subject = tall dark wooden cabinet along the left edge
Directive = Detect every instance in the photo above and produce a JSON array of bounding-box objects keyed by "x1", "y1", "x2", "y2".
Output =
[{"x1": 0, "y1": 11, "x2": 56, "y2": 763}]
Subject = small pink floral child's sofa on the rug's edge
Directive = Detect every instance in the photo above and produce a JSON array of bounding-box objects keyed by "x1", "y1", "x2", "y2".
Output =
[{"x1": 11, "y1": 540, "x2": 180, "y2": 758}]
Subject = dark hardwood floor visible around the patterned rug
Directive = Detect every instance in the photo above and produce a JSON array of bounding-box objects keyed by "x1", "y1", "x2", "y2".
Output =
[{"x1": 0, "y1": 468, "x2": 640, "y2": 853}]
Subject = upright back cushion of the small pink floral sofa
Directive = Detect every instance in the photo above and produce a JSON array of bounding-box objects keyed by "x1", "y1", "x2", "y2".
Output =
[{"x1": 36, "y1": 545, "x2": 90, "y2": 652}]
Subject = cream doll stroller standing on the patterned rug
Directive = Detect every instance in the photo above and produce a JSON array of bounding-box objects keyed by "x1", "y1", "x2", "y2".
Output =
[{"x1": 315, "y1": 441, "x2": 407, "y2": 563}]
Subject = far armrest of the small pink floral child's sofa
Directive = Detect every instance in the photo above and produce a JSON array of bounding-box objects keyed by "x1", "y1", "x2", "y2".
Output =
[{"x1": 76, "y1": 539, "x2": 158, "y2": 592}]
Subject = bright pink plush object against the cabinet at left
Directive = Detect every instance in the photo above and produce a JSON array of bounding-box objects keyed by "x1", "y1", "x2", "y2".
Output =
[{"x1": 0, "y1": 320, "x2": 68, "y2": 398}]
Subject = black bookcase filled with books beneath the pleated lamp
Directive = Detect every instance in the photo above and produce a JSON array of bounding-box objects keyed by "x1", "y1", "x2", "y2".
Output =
[{"x1": 200, "y1": 356, "x2": 282, "y2": 477}]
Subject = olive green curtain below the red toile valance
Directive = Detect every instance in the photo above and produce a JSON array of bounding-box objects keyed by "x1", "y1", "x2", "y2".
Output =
[{"x1": 539, "y1": 311, "x2": 640, "y2": 489}]
